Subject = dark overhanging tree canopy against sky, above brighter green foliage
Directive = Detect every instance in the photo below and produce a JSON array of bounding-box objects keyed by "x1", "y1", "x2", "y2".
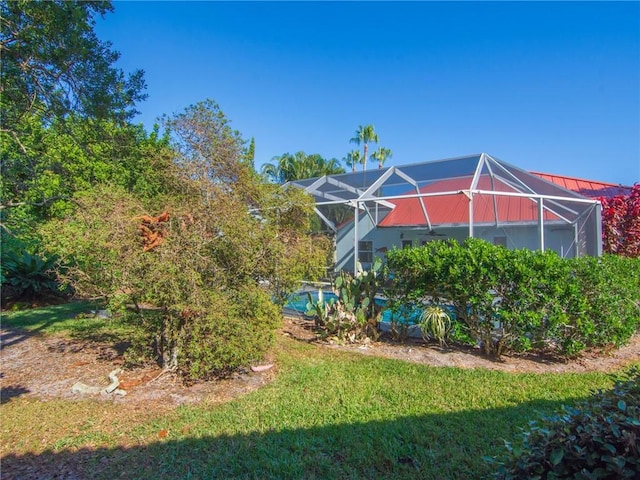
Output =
[{"x1": 0, "y1": 0, "x2": 145, "y2": 142}]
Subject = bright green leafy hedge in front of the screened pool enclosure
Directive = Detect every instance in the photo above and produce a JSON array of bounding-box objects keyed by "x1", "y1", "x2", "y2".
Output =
[{"x1": 387, "y1": 239, "x2": 640, "y2": 356}]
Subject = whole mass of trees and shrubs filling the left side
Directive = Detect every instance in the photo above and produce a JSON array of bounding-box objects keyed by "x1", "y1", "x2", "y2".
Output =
[{"x1": 0, "y1": 0, "x2": 328, "y2": 378}]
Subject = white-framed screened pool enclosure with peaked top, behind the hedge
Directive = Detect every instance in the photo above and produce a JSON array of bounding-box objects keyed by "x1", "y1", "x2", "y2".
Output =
[{"x1": 291, "y1": 153, "x2": 601, "y2": 270}]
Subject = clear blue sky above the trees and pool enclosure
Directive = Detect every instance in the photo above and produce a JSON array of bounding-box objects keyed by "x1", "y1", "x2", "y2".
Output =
[{"x1": 96, "y1": 1, "x2": 640, "y2": 185}]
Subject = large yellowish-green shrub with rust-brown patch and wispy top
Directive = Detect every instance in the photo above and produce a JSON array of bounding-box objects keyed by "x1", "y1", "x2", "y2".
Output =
[{"x1": 40, "y1": 101, "x2": 326, "y2": 378}]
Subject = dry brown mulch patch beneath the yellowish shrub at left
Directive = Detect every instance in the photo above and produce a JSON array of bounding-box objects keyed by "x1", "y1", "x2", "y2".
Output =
[{"x1": 0, "y1": 329, "x2": 275, "y2": 412}]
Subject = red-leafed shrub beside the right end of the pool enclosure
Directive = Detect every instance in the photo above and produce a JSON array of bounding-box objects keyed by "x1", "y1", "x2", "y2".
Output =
[{"x1": 600, "y1": 183, "x2": 640, "y2": 257}]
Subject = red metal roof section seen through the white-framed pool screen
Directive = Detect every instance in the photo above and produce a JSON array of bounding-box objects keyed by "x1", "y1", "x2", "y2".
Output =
[{"x1": 379, "y1": 175, "x2": 558, "y2": 227}]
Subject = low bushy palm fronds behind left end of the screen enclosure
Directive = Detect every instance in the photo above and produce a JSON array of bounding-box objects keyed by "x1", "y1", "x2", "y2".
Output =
[{"x1": 261, "y1": 151, "x2": 344, "y2": 183}]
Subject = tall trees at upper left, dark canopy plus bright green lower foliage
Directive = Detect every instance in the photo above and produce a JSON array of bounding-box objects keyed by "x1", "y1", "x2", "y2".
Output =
[{"x1": 0, "y1": 0, "x2": 151, "y2": 225}]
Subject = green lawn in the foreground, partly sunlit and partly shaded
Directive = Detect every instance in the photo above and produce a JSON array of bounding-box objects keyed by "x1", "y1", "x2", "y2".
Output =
[{"x1": 2, "y1": 307, "x2": 632, "y2": 479}]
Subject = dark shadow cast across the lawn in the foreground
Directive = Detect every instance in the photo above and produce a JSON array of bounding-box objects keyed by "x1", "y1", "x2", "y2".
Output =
[{"x1": 2, "y1": 399, "x2": 576, "y2": 480}]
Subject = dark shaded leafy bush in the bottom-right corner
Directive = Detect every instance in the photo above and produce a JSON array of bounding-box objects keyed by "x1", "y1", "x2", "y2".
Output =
[{"x1": 487, "y1": 368, "x2": 640, "y2": 480}]
